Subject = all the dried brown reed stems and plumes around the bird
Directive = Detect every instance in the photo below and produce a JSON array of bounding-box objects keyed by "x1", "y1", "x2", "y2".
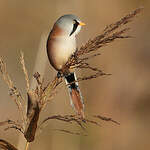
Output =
[{"x1": 0, "y1": 8, "x2": 142, "y2": 150}]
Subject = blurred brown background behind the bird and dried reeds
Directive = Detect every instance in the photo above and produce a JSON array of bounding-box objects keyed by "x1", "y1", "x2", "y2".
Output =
[{"x1": 0, "y1": 0, "x2": 150, "y2": 150}]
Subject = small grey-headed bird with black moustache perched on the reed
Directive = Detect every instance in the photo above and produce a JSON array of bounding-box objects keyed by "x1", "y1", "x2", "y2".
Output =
[{"x1": 46, "y1": 14, "x2": 85, "y2": 119}]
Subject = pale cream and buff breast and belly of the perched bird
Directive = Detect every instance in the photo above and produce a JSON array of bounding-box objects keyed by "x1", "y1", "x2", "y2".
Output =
[{"x1": 47, "y1": 37, "x2": 76, "y2": 70}]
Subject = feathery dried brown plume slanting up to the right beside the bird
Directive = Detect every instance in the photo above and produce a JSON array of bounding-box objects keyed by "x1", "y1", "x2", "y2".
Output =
[{"x1": 62, "y1": 7, "x2": 143, "y2": 81}]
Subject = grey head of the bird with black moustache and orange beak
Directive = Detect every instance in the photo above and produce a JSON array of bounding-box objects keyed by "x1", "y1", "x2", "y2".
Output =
[{"x1": 55, "y1": 14, "x2": 85, "y2": 36}]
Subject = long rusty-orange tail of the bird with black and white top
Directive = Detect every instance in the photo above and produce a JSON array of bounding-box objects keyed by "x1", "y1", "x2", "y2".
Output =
[{"x1": 65, "y1": 73, "x2": 84, "y2": 119}]
